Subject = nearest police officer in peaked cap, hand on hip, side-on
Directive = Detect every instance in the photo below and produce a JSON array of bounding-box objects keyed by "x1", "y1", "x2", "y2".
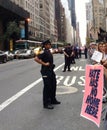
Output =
[{"x1": 34, "y1": 40, "x2": 60, "y2": 109}]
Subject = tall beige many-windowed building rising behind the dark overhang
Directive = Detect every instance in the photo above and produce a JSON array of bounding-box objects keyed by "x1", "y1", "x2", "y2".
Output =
[{"x1": 6, "y1": 0, "x2": 55, "y2": 40}]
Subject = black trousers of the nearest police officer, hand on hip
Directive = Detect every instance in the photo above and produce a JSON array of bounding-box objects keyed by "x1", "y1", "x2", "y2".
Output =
[{"x1": 41, "y1": 69, "x2": 57, "y2": 106}]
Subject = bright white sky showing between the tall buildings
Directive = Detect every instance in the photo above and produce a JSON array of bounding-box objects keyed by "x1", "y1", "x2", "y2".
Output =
[{"x1": 61, "y1": 0, "x2": 89, "y2": 45}]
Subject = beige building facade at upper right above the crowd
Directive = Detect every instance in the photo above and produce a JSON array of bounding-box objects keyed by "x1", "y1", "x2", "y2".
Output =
[{"x1": 86, "y1": 0, "x2": 106, "y2": 41}]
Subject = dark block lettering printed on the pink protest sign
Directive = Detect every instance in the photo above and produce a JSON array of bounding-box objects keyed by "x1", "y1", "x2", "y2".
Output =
[{"x1": 85, "y1": 69, "x2": 101, "y2": 118}]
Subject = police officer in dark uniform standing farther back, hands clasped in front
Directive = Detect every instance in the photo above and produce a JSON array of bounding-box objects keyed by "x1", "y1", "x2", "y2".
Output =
[{"x1": 63, "y1": 44, "x2": 72, "y2": 72}]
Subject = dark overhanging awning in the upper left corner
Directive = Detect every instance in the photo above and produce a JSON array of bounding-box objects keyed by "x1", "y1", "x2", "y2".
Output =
[{"x1": 0, "y1": 0, "x2": 30, "y2": 20}]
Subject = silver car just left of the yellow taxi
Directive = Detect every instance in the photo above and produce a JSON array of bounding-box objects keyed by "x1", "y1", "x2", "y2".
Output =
[{"x1": 15, "y1": 49, "x2": 34, "y2": 59}]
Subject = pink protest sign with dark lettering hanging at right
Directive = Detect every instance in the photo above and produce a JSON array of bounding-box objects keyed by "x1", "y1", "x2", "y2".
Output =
[{"x1": 81, "y1": 65, "x2": 104, "y2": 127}]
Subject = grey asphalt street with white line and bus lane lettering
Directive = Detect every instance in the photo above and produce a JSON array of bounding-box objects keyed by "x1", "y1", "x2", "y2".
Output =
[{"x1": 0, "y1": 54, "x2": 102, "y2": 130}]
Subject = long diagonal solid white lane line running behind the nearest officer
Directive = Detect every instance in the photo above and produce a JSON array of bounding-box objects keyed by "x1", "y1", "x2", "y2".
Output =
[{"x1": 0, "y1": 63, "x2": 64, "y2": 111}]
